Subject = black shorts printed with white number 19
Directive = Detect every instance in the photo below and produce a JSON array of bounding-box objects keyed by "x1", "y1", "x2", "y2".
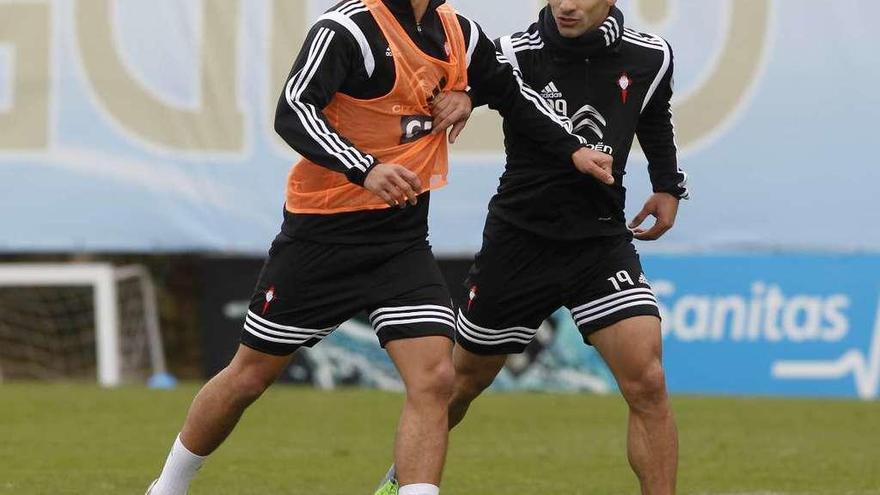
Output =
[{"x1": 456, "y1": 215, "x2": 660, "y2": 355}]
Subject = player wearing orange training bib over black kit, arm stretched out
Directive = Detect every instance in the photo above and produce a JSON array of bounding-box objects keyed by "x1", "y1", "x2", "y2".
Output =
[{"x1": 147, "y1": 0, "x2": 613, "y2": 495}]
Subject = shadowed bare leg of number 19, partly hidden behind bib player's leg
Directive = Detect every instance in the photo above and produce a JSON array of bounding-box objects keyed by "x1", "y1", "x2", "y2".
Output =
[{"x1": 449, "y1": 346, "x2": 507, "y2": 430}]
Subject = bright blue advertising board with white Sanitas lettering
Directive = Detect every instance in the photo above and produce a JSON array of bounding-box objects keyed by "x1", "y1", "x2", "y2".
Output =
[{"x1": 645, "y1": 255, "x2": 880, "y2": 399}]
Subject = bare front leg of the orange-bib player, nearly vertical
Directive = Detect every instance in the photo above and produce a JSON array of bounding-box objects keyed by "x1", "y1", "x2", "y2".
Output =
[{"x1": 386, "y1": 336, "x2": 454, "y2": 487}]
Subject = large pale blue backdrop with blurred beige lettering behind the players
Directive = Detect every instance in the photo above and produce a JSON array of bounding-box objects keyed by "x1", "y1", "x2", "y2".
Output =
[{"x1": 0, "y1": 0, "x2": 880, "y2": 255}]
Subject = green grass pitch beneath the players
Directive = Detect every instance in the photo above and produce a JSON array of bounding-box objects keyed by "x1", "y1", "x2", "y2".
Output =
[{"x1": 0, "y1": 384, "x2": 880, "y2": 495}]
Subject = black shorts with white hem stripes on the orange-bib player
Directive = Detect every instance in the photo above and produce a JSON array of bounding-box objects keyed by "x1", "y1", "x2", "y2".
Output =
[{"x1": 241, "y1": 233, "x2": 455, "y2": 356}]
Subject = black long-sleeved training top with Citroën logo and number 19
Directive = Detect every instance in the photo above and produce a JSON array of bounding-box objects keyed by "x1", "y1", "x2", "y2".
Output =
[{"x1": 476, "y1": 7, "x2": 688, "y2": 240}]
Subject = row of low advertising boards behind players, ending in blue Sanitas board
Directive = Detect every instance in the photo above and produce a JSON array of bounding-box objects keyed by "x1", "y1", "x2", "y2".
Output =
[{"x1": 203, "y1": 255, "x2": 880, "y2": 399}]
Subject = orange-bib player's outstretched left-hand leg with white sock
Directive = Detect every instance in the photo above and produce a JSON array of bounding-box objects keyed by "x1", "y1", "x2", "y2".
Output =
[{"x1": 147, "y1": 345, "x2": 291, "y2": 495}]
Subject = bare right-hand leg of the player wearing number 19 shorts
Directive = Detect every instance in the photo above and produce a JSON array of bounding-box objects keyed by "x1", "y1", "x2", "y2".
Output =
[{"x1": 590, "y1": 316, "x2": 678, "y2": 495}]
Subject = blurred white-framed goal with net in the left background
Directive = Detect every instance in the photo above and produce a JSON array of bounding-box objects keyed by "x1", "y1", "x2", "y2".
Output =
[{"x1": 0, "y1": 263, "x2": 173, "y2": 386}]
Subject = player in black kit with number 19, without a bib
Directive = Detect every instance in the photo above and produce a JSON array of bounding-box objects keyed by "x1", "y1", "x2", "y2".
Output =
[{"x1": 378, "y1": 0, "x2": 688, "y2": 495}]
